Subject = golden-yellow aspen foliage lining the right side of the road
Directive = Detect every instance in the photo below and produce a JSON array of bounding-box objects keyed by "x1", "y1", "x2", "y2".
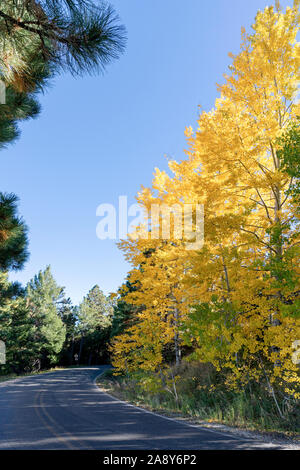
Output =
[{"x1": 112, "y1": 0, "x2": 300, "y2": 397}]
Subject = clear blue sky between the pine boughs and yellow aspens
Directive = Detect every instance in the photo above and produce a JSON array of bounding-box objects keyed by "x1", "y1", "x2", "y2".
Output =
[{"x1": 0, "y1": 0, "x2": 292, "y2": 303}]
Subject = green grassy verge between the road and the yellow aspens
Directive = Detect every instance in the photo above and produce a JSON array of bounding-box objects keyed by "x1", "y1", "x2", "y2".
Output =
[{"x1": 97, "y1": 365, "x2": 300, "y2": 439}]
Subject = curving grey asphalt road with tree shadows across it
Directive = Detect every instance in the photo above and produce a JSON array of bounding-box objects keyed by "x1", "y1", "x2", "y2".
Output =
[{"x1": 0, "y1": 366, "x2": 290, "y2": 450}]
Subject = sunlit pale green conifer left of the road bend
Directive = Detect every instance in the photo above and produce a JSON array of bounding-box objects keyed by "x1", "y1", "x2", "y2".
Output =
[{"x1": 26, "y1": 266, "x2": 66, "y2": 367}]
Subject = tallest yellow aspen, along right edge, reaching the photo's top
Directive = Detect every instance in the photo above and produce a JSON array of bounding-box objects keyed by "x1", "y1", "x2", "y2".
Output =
[{"x1": 173, "y1": 1, "x2": 300, "y2": 392}]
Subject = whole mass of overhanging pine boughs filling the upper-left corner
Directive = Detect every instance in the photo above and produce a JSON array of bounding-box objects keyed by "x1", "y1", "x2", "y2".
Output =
[{"x1": 0, "y1": 0, "x2": 125, "y2": 148}]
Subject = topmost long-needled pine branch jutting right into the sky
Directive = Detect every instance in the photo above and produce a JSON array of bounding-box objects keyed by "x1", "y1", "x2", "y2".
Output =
[{"x1": 0, "y1": 0, "x2": 126, "y2": 75}]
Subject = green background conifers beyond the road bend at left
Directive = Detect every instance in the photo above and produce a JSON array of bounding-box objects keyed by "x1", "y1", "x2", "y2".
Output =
[{"x1": 0, "y1": 260, "x2": 118, "y2": 374}]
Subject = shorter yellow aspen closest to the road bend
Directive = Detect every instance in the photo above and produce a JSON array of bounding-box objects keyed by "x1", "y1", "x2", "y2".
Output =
[{"x1": 113, "y1": 231, "x2": 191, "y2": 370}]
